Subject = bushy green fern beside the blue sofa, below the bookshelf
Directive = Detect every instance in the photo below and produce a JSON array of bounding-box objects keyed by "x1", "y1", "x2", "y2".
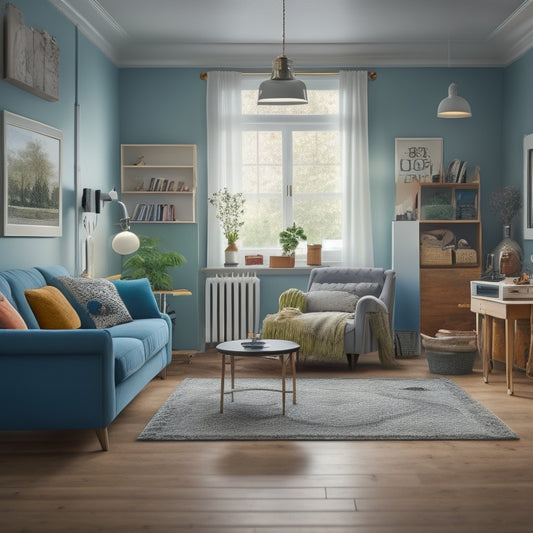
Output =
[{"x1": 121, "y1": 236, "x2": 186, "y2": 291}]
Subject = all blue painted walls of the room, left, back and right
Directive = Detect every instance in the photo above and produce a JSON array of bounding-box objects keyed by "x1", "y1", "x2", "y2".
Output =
[{"x1": 0, "y1": 0, "x2": 533, "y2": 349}]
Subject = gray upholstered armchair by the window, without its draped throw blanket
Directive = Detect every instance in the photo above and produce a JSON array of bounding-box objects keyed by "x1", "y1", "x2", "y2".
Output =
[{"x1": 307, "y1": 267, "x2": 396, "y2": 368}]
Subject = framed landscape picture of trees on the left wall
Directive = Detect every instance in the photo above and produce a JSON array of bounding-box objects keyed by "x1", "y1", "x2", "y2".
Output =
[{"x1": 0, "y1": 111, "x2": 63, "y2": 237}]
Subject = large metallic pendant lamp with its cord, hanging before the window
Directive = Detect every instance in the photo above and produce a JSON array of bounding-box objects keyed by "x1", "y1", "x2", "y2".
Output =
[{"x1": 257, "y1": 0, "x2": 307, "y2": 105}]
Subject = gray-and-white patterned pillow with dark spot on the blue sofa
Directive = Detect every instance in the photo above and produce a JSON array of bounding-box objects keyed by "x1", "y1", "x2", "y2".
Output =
[{"x1": 58, "y1": 276, "x2": 132, "y2": 329}]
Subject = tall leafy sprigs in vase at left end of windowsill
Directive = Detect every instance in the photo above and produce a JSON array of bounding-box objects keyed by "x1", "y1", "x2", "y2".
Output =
[{"x1": 208, "y1": 187, "x2": 246, "y2": 266}]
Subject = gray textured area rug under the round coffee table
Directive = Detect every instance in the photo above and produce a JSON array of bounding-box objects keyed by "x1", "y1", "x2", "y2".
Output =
[{"x1": 138, "y1": 378, "x2": 518, "y2": 441}]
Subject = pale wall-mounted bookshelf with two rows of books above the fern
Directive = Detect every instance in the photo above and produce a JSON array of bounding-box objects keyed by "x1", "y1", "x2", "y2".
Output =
[{"x1": 120, "y1": 144, "x2": 196, "y2": 224}]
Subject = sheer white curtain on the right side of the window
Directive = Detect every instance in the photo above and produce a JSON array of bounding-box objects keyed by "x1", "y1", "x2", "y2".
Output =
[{"x1": 339, "y1": 70, "x2": 374, "y2": 267}]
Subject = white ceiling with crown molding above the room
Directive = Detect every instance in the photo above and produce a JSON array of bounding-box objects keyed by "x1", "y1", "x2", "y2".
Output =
[{"x1": 49, "y1": 0, "x2": 533, "y2": 70}]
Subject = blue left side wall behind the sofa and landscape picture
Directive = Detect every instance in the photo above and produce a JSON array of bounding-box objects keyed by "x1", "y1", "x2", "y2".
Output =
[{"x1": 0, "y1": 0, "x2": 120, "y2": 275}]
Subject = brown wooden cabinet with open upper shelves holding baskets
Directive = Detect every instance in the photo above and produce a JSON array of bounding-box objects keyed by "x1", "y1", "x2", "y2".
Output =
[{"x1": 419, "y1": 183, "x2": 482, "y2": 335}]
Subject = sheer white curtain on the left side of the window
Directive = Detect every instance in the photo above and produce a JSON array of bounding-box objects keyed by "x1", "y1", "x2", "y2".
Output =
[{"x1": 206, "y1": 71, "x2": 242, "y2": 267}]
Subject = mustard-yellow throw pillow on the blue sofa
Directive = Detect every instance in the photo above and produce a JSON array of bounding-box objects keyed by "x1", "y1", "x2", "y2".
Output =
[{"x1": 24, "y1": 285, "x2": 81, "y2": 329}]
